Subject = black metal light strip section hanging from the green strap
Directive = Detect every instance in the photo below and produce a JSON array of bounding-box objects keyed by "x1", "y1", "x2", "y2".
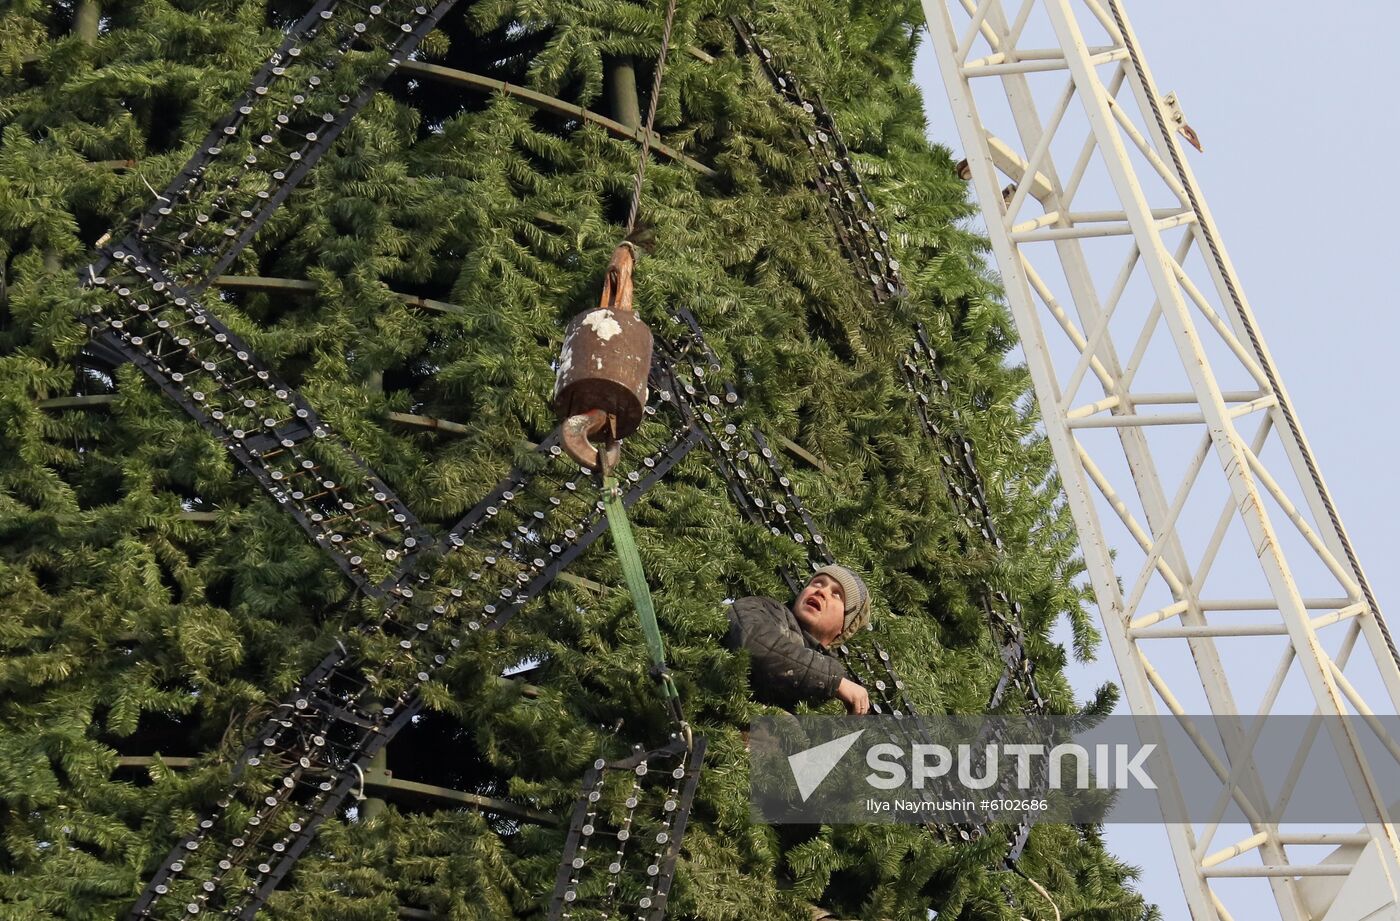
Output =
[{"x1": 547, "y1": 736, "x2": 706, "y2": 921}]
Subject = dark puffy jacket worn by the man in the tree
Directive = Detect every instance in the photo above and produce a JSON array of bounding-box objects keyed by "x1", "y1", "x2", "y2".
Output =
[{"x1": 725, "y1": 596, "x2": 846, "y2": 710}]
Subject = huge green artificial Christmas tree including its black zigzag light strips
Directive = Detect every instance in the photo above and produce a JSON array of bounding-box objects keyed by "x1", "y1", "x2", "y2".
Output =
[{"x1": 0, "y1": 1, "x2": 1149, "y2": 920}]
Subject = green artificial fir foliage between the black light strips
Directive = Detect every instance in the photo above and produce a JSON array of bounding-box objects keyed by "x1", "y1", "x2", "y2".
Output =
[{"x1": 0, "y1": 0, "x2": 1158, "y2": 921}]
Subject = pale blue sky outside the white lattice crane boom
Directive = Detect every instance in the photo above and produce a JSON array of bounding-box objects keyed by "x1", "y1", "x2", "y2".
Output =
[{"x1": 916, "y1": 0, "x2": 1400, "y2": 921}]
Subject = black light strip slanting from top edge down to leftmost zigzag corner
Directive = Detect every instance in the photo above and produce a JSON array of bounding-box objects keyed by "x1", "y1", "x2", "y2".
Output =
[{"x1": 94, "y1": 0, "x2": 455, "y2": 291}]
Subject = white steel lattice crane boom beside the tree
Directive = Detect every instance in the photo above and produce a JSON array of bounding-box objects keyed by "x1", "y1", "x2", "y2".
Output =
[{"x1": 924, "y1": 0, "x2": 1400, "y2": 921}]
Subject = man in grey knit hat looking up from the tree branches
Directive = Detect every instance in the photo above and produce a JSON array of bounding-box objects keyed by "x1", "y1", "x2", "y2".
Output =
[{"x1": 725, "y1": 564, "x2": 871, "y2": 714}]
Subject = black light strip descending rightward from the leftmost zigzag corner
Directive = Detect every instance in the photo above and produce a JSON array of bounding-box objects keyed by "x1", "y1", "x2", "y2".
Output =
[{"x1": 88, "y1": 249, "x2": 427, "y2": 595}]
